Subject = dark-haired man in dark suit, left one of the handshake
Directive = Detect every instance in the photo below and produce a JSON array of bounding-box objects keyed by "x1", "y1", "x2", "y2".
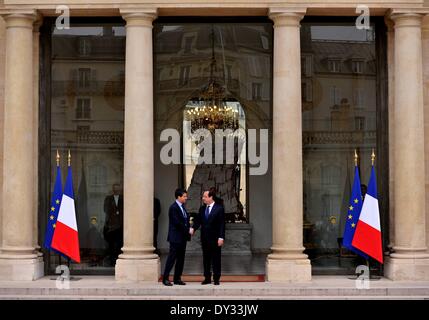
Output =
[{"x1": 162, "y1": 189, "x2": 191, "y2": 286}]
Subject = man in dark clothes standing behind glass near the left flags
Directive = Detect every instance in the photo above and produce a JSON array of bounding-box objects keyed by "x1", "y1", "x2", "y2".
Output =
[{"x1": 103, "y1": 183, "x2": 124, "y2": 265}]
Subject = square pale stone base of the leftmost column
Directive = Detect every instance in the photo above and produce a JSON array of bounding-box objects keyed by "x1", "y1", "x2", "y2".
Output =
[{"x1": 0, "y1": 257, "x2": 45, "y2": 281}]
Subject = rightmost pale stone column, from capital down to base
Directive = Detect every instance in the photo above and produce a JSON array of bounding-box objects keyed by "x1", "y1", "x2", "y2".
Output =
[{"x1": 385, "y1": 13, "x2": 429, "y2": 280}]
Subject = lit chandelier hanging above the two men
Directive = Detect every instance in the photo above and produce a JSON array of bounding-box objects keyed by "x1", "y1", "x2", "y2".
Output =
[{"x1": 185, "y1": 26, "x2": 239, "y2": 132}]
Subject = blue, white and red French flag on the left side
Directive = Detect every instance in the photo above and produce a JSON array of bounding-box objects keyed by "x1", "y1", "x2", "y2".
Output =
[{"x1": 51, "y1": 166, "x2": 80, "y2": 263}]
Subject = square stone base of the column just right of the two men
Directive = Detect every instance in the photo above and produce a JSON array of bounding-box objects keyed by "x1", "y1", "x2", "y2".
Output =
[{"x1": 265, "y1": 258, "x2": 311, "y2": 282}]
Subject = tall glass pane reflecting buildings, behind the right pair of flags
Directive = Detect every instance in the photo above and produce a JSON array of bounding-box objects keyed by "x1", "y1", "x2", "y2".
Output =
[{"x1": 301, "y1": 23, "x2": 377, "y2": 273}]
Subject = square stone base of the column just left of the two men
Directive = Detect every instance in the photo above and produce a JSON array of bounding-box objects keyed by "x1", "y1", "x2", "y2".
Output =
[{"x1": 115, "y1": 257, "x2": 161, "y2": 282}]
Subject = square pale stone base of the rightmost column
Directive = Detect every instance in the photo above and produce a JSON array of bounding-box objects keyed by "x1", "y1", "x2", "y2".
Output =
[{"x1": 384, "y1": 257, "x2": 429, "y2": 281}]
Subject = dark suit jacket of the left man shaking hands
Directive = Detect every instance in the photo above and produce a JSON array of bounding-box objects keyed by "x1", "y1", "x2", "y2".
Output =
[{"x1": 167, "y1": 201, "x2": 191, "y2": 243}]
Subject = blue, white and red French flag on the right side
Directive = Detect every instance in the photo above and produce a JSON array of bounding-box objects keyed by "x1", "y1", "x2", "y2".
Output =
[{"x1": 352, "y1": 166, "x2": 383, "y2": 263}]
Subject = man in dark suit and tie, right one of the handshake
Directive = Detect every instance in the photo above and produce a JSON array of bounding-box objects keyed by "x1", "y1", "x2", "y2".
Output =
[{"x1": 191, "y1": 189, "x2": 225, "y2": 285}]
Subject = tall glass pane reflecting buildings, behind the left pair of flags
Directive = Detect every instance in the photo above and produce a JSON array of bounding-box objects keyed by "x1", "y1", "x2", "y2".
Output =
[{"x1": 50, "y1": 24, "x2": 125, "y2": 272}]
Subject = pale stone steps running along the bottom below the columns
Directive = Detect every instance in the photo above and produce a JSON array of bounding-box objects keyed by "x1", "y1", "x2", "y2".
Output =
[{"x1": 0, "y1": 276, "x2": 429, "y2": 300}]
